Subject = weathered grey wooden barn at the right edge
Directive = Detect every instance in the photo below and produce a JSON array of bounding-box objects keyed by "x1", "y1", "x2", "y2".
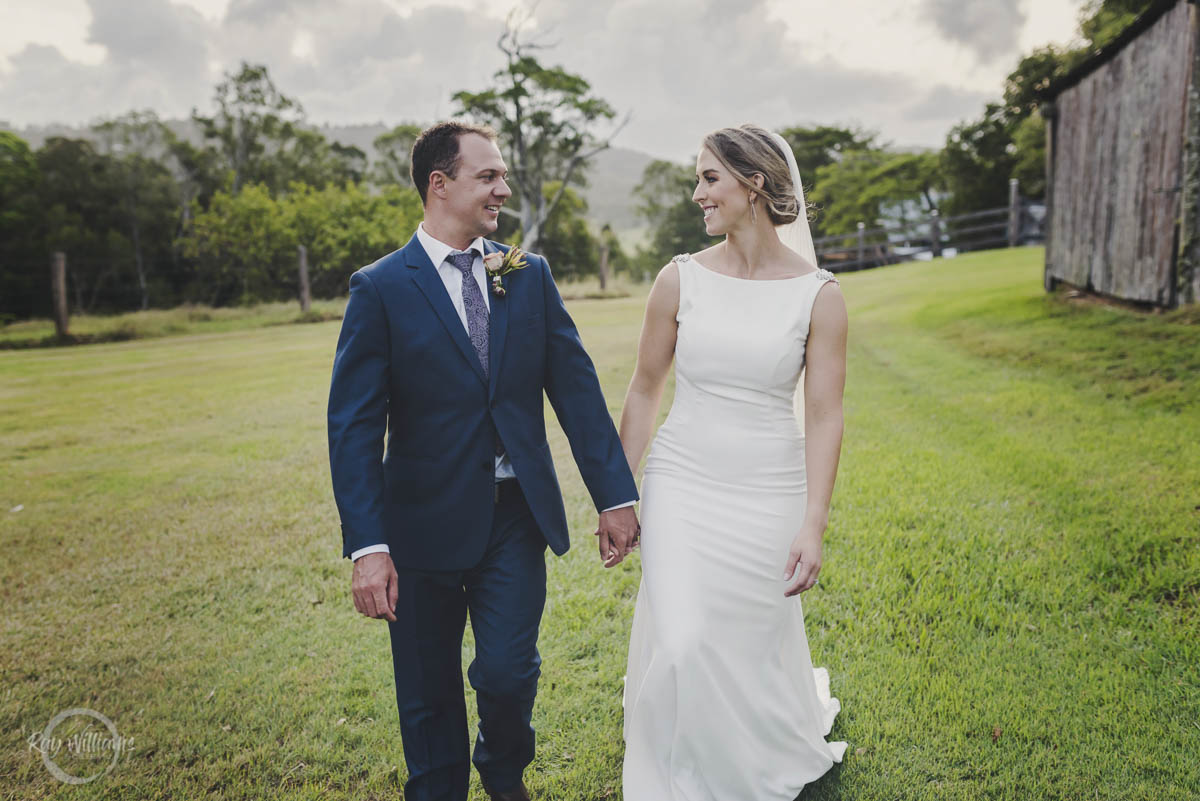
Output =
[{"x1": 1042, "y1": 0, "x2": 1200, "y2": 307}]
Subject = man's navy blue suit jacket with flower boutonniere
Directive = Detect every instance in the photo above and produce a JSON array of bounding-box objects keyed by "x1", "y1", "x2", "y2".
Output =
[{"x1": 329, "y1": 235, "x2": 637, "y2": 570}]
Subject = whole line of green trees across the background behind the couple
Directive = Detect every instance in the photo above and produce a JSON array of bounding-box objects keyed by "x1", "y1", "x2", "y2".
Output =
[{"x1": 0, "y1": 0, "x2": 1151, "y2": 321}]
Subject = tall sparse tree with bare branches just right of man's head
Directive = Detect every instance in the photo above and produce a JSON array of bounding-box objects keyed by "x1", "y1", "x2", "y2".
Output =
[{"x1": 454, "y1": 13, "x2": 623, "y2": 249}]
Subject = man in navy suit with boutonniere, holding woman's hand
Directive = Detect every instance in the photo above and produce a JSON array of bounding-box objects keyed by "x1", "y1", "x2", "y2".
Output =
[{"x1": 329, "y1": 122, "x2": 637, "y2": 801}]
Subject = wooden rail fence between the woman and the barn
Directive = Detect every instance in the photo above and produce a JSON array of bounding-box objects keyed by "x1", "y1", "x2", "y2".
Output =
[{"x1": 812, "y1": 179, "x2": 1044, "y2": 272}]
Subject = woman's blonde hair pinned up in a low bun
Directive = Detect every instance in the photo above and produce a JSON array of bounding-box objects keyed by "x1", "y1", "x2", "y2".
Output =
[{"x1": 701, "y1": 125, "x2": 800, "y2": 225}]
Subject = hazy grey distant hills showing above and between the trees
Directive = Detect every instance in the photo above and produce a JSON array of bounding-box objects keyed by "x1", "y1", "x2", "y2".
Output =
[{"x1": 0, "y1": 120, "x2": 654, "y2": 235}]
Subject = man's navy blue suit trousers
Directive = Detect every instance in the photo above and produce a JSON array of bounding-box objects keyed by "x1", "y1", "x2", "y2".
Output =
[{"x1": 388, "y1": 480, "x2": 546, "y2": 801}]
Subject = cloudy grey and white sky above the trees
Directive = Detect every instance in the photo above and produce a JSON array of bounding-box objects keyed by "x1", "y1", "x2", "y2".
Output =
[{"x1": 0, "y1": 0, "x2": 1082, "y2": 158}]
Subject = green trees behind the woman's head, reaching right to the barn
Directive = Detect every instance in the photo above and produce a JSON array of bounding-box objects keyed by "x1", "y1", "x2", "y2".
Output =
[{"x1": 636, "y1": 0, "x2": 1153, "y2": 270}]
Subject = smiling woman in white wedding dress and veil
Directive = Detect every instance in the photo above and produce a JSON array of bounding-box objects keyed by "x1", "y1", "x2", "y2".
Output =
[{"x1": 609, "y1": 125, "x2": 846, "y2": 801}]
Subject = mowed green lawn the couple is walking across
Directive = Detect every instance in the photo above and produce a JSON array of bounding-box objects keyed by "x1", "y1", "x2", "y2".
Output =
[{"x1": 0, "y1": 248, "x2": 1200, "y2": 801}]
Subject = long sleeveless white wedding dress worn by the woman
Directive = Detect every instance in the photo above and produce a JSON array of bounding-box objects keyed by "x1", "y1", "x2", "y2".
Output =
[{"x1": 624, "y1": 255, "x2": 846, "y2": 801}]
